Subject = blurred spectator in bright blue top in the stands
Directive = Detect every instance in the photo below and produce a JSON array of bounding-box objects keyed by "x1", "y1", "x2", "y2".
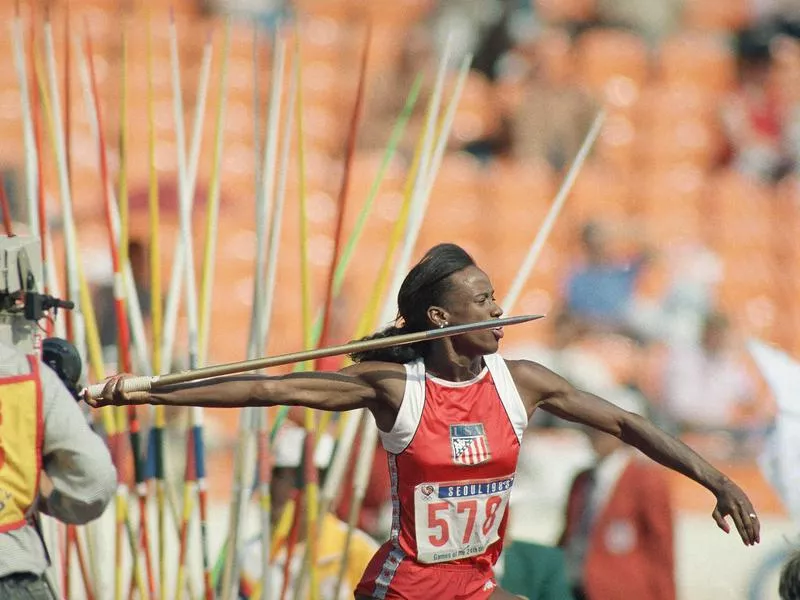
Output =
[{"x1": 565, "y1": 221, "x2": 651, "y2": 329}]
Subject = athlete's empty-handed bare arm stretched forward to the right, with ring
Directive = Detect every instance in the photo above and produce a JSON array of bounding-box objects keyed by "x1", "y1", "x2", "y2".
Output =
[{"x1": 508, "y1": 360, "x2": 760, "y2": 545}]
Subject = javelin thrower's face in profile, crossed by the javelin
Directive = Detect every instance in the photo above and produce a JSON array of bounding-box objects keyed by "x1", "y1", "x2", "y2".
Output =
[{"x1": 428, "y1": 266, "x2": 503, "y2": 355}]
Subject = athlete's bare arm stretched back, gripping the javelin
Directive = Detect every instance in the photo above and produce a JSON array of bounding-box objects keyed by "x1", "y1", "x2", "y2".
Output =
[{"x1": 92, "y1": 362, "x2": 405, "y2": 430}]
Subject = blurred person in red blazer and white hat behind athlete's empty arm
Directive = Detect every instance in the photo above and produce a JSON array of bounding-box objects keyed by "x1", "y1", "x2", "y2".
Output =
[{"x1": 559, "y1": 391, "x2": 676, "y2": 600}]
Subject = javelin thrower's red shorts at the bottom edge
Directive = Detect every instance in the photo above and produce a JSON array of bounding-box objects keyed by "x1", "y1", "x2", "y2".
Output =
[{"x1": 355, "y1": 542, "x2": 497, "y2": 600}]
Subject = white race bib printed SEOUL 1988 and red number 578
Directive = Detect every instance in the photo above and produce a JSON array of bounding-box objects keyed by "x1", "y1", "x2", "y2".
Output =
[{"x1": 414, "y1": 475, "x2": 514, "y2": 564}]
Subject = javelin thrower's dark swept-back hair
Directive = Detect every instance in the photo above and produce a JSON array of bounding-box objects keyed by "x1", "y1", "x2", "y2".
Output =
[{"x1": 351, "y1": 244, "x2": 475, "y2": 363}]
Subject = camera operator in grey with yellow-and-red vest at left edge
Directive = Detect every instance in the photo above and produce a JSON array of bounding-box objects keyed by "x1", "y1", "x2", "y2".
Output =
[{"x1": 0, "y1": 339, "x2": 117, "y2": 600}]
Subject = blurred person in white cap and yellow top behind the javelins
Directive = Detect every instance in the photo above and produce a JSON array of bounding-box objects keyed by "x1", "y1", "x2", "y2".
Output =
[{"x1": 239, "y1": 424, "x2": 378, "y2": 600}]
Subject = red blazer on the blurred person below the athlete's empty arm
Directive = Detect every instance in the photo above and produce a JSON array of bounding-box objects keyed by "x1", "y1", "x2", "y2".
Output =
[{"x1": 561, "y1": 459, "x2": 675, "y2": 600}]
